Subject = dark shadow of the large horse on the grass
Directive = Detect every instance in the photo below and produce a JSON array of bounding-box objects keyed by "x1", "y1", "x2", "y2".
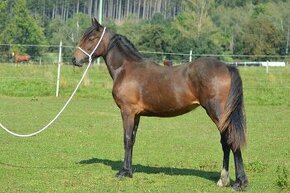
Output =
[{"x1": 78, "y1": 158, "x2": 219, "y2": 182}]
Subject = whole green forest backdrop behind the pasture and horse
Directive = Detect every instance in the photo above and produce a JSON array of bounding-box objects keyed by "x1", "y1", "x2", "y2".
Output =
[{"x1": 0, "y1": 0, "x2": 290, "y2": 62}]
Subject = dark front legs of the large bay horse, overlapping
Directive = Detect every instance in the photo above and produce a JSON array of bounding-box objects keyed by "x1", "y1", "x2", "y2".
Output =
[{"x1": 116, "y1": 113, "x2": 140, "y2": 178}]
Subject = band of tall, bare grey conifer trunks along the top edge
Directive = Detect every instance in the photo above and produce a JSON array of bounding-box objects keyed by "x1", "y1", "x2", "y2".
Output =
[{"x1": 25, "y1": 0, "x2": 182, "y2": 22}]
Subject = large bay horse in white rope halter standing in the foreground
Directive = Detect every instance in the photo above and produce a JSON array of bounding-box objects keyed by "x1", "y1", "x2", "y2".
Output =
[{"x1": 72, "y1": 18, "x2": 248, "y2": 190}]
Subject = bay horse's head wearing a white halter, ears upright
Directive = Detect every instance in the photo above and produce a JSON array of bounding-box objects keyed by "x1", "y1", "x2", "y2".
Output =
[{"x1": 73, "y1": 18, "x2": 107, "y2": 66}]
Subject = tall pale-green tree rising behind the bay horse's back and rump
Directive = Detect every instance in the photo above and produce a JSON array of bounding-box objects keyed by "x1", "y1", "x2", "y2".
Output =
[{"x1": 172, "y1": 0, "x2": 225, "y2": 58}]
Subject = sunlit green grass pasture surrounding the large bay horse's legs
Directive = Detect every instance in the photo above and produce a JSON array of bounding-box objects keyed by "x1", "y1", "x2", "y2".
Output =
[{"x1": 0, "y1": 64, "x2": 290, "y2": 193}]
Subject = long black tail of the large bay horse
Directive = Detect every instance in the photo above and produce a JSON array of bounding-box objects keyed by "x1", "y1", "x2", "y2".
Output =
[{"x1": 219, "y1": 66, "x2": 246, "y2": 151}]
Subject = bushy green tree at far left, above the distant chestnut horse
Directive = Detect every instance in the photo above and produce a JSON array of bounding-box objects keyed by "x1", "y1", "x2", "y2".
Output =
[{"x1": 0, "y1": 0, "x2": 46, "y2": 57}]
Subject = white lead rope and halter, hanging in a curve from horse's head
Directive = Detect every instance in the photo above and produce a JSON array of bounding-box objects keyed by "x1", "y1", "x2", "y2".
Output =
[{"x1": 0, "y1": 27, "x2": 106, "y2": 137}]
